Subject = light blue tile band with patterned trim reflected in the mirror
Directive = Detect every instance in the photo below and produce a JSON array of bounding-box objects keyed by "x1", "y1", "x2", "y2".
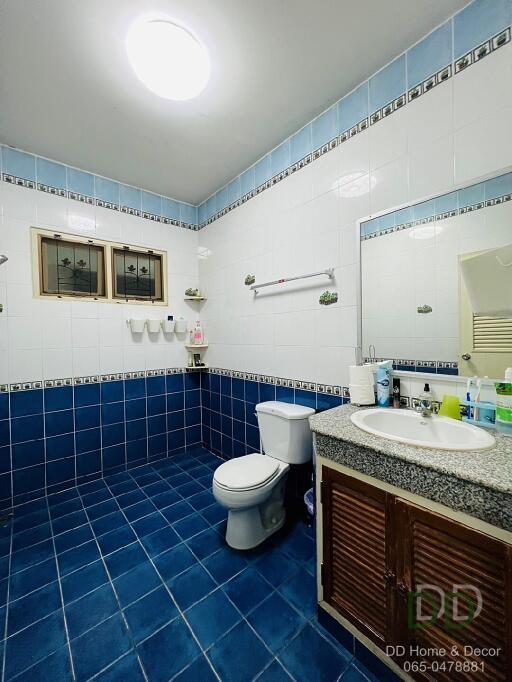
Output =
[{"x1": 361, "y1": 173, "x2": 512, "y2": 241}]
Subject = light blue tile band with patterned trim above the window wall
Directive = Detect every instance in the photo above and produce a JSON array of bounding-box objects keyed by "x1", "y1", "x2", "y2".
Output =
[{"x1": 0, "y1": 145, "x2": 198, "y2": 230}]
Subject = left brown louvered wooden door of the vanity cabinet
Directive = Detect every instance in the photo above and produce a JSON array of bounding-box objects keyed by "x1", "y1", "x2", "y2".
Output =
[{"x1": 322, "y1": 467, "x2": 394, "y2": 647}]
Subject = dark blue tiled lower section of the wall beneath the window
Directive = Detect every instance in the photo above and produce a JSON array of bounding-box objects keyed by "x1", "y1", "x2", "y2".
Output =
[{"x1": 0, "y1": 369, "x2": 202, "y2": 509}]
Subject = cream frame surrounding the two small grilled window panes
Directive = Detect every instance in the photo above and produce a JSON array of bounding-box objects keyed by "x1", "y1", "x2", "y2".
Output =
[{"x1": 31, "y1": 227, "x2": 168, "y2": 306}]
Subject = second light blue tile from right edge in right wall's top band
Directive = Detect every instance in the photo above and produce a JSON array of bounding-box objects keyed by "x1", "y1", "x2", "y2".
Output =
[{"x1": 407, "y1": 20, "x2": 453, "y2": 88}]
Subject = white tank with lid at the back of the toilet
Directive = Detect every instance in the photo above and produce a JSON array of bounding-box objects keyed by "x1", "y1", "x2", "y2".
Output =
[{"x1": 256, "y1": 400, "x2": 315, "y2": 464}]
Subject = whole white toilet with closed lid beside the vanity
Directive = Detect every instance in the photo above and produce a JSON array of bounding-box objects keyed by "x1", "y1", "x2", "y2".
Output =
[{"x1": 212, "y1": 400, "x2": 315, "y2": 549}]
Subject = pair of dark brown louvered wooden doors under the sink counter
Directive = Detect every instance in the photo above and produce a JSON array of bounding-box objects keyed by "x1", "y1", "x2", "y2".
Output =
[{"x1": 321, "y1": 466, "x2": 512, "y2": 682}]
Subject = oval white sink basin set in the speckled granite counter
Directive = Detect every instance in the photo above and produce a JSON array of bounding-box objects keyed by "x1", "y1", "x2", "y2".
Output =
[{"x1": 350, "y1": 408, "x2": 495, "y2": 450}]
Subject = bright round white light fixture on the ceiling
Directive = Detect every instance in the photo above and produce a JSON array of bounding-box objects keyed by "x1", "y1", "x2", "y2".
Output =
[{"x1": 126, "y1": 19, "x2": 210, "y2": 100}]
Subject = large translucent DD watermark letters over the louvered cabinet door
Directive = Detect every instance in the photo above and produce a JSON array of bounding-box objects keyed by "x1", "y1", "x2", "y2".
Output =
[{"x1": 407, "y1": 583, "x2": 483, "y2": 630}]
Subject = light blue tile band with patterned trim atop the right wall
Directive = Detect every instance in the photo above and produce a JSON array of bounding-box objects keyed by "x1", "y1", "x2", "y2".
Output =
[{"x1": 198, "y1": 0, "x2": 512, "y2": 228}]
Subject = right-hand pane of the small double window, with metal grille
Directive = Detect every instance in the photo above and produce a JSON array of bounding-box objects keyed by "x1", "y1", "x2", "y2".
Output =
[{"x1": 112, "y1": 246, "x2": 163, "y2": 301}]
